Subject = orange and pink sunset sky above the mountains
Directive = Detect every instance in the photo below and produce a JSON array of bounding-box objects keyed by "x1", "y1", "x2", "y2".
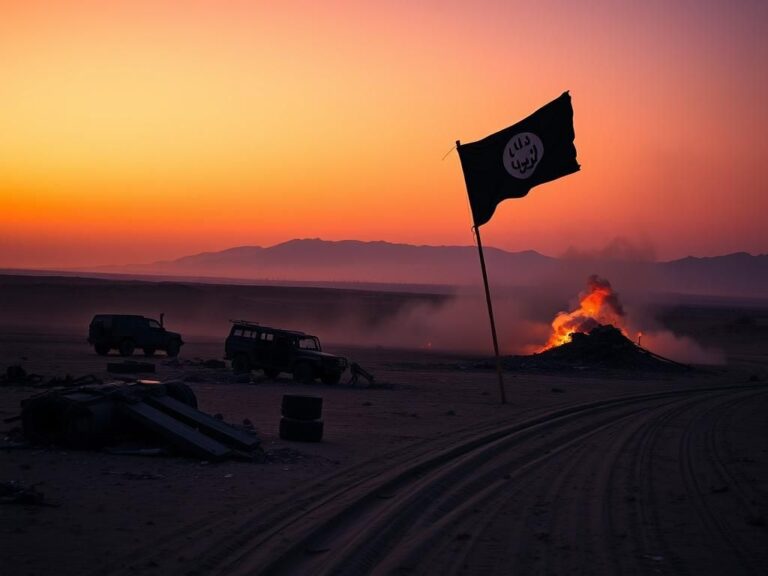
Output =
[{"x1": 0, "y1": 0, "x2": 768, "y2": 267}]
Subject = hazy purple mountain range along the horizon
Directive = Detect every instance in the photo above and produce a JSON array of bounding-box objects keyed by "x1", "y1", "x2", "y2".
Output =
[{"x1": 93, "y1": 239, "x2": 768, "y2": 297}]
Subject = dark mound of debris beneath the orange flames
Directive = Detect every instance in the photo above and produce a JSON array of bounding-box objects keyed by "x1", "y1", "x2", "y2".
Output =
[{"x1": 505, "y1": 324, "x2": 690, "y2": 371}]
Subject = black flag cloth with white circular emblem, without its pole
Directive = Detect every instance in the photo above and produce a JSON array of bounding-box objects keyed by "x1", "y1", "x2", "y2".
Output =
[{"x1": 458, "y1": 92, "x2": 579, "y2": 226}]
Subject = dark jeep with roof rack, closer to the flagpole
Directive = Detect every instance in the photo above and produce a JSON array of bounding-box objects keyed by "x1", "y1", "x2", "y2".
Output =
[{"x1": 224, "y1": 320, "x2": 348, "y2": 384}]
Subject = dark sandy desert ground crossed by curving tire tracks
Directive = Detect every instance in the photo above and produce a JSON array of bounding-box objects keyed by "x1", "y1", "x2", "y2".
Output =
[{"x1": 0, "y1": 276, "x2": 768, "y2": 576}]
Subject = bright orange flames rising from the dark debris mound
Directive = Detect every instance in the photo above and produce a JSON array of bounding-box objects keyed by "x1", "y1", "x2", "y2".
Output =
[{"x1": 540, "y1": 274, "x2": 627, "y2": 352}]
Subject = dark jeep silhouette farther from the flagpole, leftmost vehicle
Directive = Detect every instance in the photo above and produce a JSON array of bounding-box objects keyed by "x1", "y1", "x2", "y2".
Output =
[{"x1": 88, "y1": 314, "x2": 184, "y2": 356}]
